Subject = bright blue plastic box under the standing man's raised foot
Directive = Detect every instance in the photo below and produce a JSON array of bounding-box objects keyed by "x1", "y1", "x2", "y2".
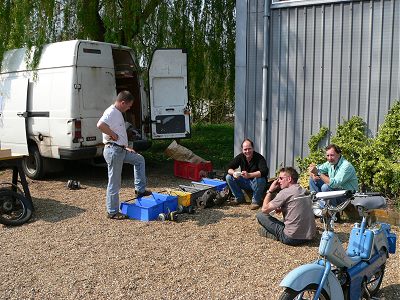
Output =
[{"x1": 120, "y1": 193, "x2": 178, "y2": 221}]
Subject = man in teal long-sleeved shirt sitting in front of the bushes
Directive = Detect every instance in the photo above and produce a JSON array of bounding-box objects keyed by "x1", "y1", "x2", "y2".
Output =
[{"x1": 308, "y1": 144, "x2": 358, "y2": 192}]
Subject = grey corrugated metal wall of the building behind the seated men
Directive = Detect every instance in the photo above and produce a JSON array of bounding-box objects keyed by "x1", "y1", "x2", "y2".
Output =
[{"x1": 235, "y1": 0, "x2": 400, "y2": 176}]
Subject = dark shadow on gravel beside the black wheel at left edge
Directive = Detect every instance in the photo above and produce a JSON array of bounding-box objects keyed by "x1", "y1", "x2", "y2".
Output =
[{"x1": 30, "y1": 198, "x2": 85, "y2": 223}]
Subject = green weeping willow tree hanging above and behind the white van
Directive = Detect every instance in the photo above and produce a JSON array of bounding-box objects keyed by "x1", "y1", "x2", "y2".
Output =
[{"x1": 0, "y1": 0, "x2": 235, "y2": 121}]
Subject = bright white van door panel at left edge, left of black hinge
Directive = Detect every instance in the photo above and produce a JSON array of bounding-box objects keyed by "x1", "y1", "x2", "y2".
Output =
[{"x1": 0, "y1": 77, "x2": 29, "y2": 155}]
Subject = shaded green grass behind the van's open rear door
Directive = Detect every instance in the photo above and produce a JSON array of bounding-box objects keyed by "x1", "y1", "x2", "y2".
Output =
[{"x1": 142, "y1": 123, "x2": 234, "y2": 170}]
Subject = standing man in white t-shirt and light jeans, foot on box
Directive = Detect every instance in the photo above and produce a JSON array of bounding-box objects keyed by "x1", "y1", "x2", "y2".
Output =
[{"x1": 97, "y1": 91, "x2": 151, "y2": 219}]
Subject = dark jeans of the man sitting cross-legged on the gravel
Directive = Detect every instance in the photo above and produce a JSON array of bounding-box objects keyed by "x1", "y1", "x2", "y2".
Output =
[{"x1": 256, "y1": 212, "x2": 310, "y2": 246}]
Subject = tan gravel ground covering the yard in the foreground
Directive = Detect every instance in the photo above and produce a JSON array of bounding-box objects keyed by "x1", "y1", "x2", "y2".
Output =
[{"x1": 0, "y1": 163, "x2": 400, "y2": 300}]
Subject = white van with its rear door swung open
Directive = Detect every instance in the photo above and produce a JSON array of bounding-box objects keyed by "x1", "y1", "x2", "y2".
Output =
[{"x1": 0, "y1": 40, "x2": 190, "y2": 179}]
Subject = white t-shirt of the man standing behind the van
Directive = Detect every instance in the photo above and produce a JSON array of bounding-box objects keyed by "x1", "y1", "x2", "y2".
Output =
[{"x1": 100, "y1": 104, "x2": 128, "y2": 146}]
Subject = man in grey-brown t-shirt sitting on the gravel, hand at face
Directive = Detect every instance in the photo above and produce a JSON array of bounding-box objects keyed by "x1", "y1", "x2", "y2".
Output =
[{"x1": 256, "y1": 167, "x2": 316, "y2": 246}]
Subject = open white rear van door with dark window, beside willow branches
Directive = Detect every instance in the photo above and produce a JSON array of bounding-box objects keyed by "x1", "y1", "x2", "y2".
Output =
[{"x1": 149, "y1": 49, "x2": 190, "y2": 139}]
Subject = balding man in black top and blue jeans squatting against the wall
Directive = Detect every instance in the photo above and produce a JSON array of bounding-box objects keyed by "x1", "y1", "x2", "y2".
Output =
[{"x1": 226, "y1": 139, "x2": 268, "y2": 210}]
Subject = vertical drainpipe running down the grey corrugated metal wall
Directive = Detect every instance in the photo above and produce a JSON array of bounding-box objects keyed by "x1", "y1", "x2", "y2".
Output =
[{"x1": 260, "y1": 0, "x2": 271, "y2": 158}]
